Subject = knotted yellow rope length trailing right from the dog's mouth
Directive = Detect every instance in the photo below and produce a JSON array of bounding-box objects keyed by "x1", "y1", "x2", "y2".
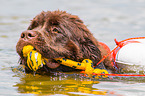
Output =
[{"x1": 55, "y1": 58, "x2": 108, "y2": 79}]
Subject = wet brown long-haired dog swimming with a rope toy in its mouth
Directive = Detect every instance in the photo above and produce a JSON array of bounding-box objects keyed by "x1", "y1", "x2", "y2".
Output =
[{"x1": 16, "y1": 10, "x2": 114, "y2": 72}]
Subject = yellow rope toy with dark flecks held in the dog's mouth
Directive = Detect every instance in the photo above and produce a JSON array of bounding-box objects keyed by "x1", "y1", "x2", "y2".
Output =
[{"x1": 22, "y1": 45, "x2": 108, "y2": 78}]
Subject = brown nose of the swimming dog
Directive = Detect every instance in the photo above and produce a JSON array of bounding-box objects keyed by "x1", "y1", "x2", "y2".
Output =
[{"x1": 21, "y1": 30, "x2": 37, "y2": 40}]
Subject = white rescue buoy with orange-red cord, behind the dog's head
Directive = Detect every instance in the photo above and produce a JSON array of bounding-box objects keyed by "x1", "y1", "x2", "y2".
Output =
[{"x1": 115, "y1": 39, "x2": 145, "y2": 66}]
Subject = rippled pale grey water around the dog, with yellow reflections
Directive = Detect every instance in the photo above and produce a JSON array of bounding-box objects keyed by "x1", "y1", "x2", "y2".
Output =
[{"x1": 0, "y1": 0, "x2": 145, "y2": 96}]
